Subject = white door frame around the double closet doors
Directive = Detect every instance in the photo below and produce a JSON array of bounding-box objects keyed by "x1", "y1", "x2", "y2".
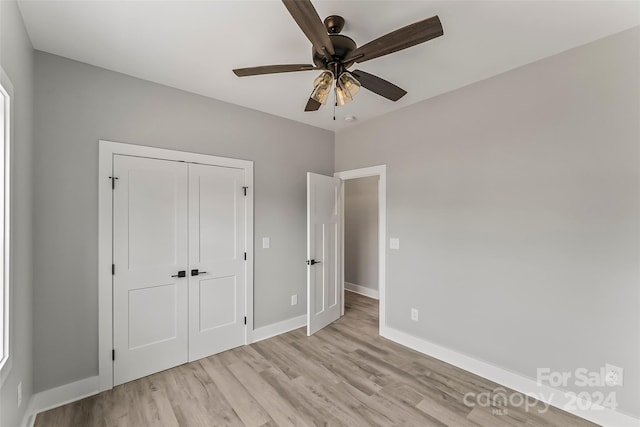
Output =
[{"x1": 98, "y1": 140, "x2": 254, "y2": 391}]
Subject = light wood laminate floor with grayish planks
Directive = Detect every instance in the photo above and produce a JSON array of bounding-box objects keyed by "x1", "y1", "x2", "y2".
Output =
[{"x1": 35, "y1": 292, "x2": 594, "y2": 427}]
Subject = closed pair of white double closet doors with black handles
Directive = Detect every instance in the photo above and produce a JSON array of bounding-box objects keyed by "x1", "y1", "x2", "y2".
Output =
[{"x1": 113, "y1": 155, "x2": 246, "y2": 385}]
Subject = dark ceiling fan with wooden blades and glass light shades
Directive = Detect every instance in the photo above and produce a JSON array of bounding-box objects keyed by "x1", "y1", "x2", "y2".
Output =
[{"x1": 233, "y1": 0, "x2": 444, "y2": 111}]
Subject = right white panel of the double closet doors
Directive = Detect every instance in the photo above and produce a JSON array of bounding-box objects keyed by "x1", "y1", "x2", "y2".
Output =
[{"x1": 189, "y1": 164, "x2": 246, "y2": 361}]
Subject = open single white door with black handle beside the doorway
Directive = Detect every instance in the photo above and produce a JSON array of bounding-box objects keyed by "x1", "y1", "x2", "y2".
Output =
[{"x1": 307, "y1": 172, "x2": 342, "y2": 335}]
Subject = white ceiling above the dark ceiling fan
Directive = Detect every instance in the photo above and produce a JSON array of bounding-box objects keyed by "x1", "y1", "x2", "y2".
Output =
[{"x1": 19, "y1": 0, "x2": 640, "y2": 130}]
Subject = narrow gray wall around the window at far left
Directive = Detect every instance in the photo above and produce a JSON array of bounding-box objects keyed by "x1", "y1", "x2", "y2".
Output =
[{"x1": 0, "y1": 1, "x2": 34, "y2": 426}]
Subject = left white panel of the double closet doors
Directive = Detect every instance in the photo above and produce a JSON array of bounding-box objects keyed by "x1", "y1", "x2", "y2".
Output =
[{"x1": 113, "y1": 155, "x2": 189, "y2": 385}]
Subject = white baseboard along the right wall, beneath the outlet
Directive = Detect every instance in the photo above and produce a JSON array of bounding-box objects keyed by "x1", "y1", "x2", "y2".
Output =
[{"x1": 380, "y1": 326, "x2": 640, "y2": 427}]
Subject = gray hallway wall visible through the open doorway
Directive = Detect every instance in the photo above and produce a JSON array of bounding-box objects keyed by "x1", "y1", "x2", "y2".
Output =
[{"x1": 344, "y1": 176, "x2": 378, "y2": 291}]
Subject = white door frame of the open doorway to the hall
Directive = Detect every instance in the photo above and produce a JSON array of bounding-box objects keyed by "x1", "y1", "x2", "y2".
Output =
[{"x1": 333, "y1": 165, "x2": 387, "y2": 335}]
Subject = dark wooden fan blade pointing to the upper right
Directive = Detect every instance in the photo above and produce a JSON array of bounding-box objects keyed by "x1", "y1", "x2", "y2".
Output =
[{"x1": 342, "y1": 16, "x2": 444, "y2": 64}]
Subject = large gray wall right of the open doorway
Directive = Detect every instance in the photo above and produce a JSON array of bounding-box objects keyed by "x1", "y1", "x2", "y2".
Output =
[{"x1": 336, "y1": 28, "x2": 640, "y2": 416}]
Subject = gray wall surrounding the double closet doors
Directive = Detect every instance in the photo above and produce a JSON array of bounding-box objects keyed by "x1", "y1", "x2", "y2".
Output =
[{"x1": 33, "y1": 52, "x2": 334, "y2": 391}]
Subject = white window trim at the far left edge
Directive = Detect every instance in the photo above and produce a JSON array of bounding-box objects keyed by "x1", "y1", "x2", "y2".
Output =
[{"x1": 0, "y1": 67, "x2": 14, "y2": 386}]
